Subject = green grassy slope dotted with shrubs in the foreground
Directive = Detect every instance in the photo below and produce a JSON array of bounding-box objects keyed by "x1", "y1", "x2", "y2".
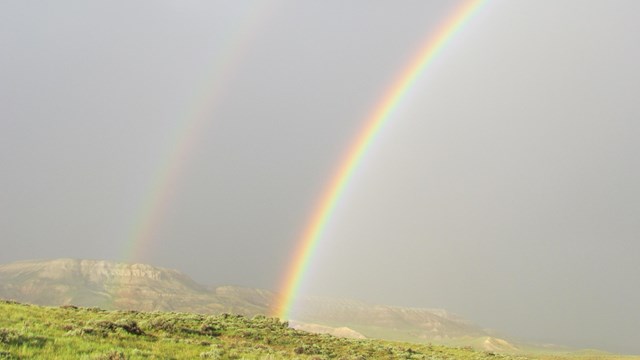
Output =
[{"x1": 0, "y1": 301, "x2": 523, "y2": 359}]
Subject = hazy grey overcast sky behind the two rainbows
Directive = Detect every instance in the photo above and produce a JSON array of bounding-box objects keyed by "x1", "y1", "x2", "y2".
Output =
[{"x1": 0, "y1": 0, "x2": 640, "y2": 353}]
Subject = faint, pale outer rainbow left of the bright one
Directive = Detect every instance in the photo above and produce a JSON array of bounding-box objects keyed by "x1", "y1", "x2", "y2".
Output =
[{"x1": 123, "y1": 0, "x2": 275, "y2": 263}]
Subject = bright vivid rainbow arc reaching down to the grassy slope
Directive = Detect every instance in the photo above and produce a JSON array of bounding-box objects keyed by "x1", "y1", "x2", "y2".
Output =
[{"x1": 272, "y1": 0, "x2": 484, "y2": 319}]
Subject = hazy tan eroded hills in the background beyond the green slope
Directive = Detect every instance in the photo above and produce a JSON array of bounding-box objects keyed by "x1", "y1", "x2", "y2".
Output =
[{"x1": 0, "y1": 259, "x2": 504, "y2": 351}]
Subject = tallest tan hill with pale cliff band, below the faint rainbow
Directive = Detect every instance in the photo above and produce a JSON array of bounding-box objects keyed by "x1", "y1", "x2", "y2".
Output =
[{"x1": 0, "y1": 259, "x2": 218, "y2": 311}]
